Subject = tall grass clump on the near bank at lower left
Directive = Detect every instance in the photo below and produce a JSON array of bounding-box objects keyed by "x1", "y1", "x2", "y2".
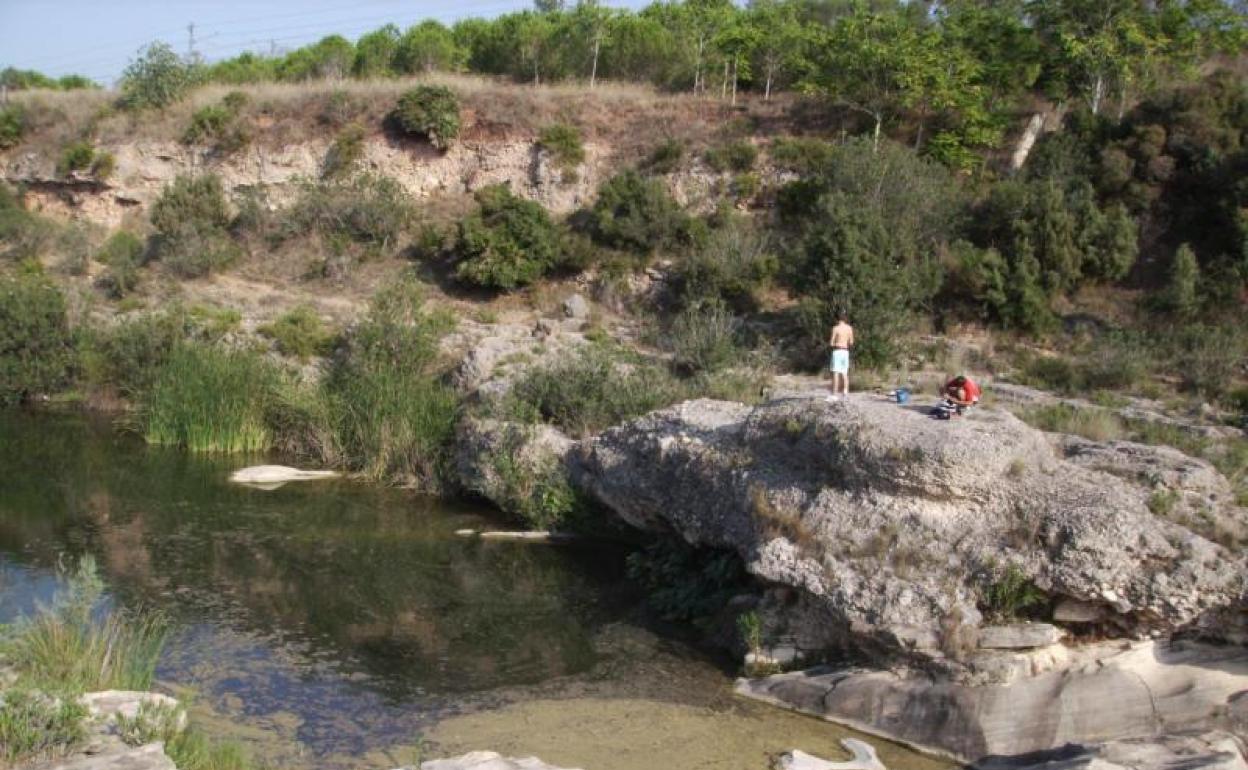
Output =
[{"x1": 4, "y1": 557, "x2": 168, "y2": 694}]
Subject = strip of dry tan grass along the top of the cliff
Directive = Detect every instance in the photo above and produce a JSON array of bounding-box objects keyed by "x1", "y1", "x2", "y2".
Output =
[{"x1": 4, "y1": 74, "x2": 791, "y2": 158}]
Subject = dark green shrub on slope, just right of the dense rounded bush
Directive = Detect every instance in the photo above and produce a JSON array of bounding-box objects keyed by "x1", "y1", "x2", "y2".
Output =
[{"x1": 585, "y1": 170, "x2": 690, "y2": 253}]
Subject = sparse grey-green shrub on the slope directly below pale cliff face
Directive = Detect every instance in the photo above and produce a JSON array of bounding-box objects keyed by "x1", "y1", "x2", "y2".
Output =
[{"x1": 280, "y1": 173, "x2": 413, "y2": 251}]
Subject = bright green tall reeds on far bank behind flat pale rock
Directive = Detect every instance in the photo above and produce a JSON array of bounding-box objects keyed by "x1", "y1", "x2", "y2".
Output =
[{"x1": 142, "y1": 343, "x2": 278, "y2": 453}]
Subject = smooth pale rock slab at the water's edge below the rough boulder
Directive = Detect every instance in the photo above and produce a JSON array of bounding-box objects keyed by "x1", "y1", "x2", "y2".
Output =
[{"x1": 738, "y1": 641, "x2": 1248, "y2": 761}]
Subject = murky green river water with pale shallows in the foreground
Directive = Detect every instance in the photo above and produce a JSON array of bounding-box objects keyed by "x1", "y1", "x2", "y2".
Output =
[{"x1": 0, "y1": 411, "x2": 941, "y2": 770}]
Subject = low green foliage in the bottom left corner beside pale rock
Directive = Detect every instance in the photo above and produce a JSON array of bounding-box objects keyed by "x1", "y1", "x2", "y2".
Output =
[{"x1": 0, "y1": 689, "x2": 87, "y2": 768}]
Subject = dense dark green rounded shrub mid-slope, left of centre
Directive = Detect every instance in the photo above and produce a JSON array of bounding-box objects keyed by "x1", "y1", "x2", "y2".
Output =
[{"x1": 453, "y1": 185, "x2": 563, "y2": 290}]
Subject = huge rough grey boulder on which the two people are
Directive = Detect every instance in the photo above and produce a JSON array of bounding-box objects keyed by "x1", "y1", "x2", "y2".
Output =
[{"x1": 572, "y1": 393, "x2": 1244, "y2": 658}]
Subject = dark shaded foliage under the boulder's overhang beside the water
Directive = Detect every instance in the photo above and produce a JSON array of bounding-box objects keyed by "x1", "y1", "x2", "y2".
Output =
[{"x1": 628, "y1": 539, "x2": 746, "y2": 621}]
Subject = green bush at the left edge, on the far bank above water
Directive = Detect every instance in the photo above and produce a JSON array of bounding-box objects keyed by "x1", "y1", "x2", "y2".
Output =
[{"x1": 0, "y1": 273, "x2": 75, "y2": 404}]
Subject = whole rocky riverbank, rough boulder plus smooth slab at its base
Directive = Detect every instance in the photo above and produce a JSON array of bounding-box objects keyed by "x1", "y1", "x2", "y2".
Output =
[{"x1": 458, "y1": 319, "x2": 1248, "y2": 766}]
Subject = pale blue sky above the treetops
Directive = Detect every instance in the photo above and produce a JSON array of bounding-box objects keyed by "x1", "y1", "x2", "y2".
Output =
[{"x1": 0, "y1": 0, "x2": 624, "y2": 85}]
